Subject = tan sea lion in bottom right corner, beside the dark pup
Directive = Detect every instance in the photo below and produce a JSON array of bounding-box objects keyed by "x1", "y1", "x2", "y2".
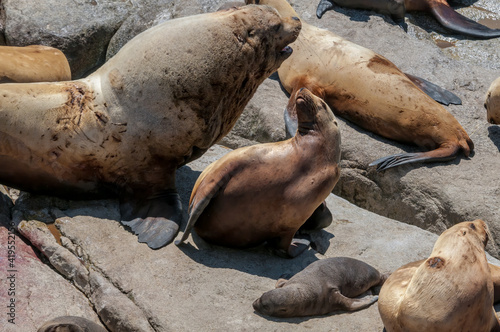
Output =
[{"x1": 378, "y1": 220, "x2": 500, "y2": 332}]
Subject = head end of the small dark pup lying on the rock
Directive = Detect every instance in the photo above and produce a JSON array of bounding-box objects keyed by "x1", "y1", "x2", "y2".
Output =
[{"x1": 252, "y1": 284, "x2": 313, "y2": 317}]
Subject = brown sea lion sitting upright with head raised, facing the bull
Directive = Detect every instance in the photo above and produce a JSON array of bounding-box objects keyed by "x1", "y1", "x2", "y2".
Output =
[{"x1": 176, "y1": 89, "x2": 340, "y2": 257}]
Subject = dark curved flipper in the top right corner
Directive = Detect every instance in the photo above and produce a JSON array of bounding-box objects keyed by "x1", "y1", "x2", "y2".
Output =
[{"x1": 430, "y1": 1, "x2": 500, "y2": 39}]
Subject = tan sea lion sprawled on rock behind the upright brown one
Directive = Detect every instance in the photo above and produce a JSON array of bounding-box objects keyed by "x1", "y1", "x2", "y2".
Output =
[{"x1": 247, "y1": 0, "x2": 473, "y2": 170}]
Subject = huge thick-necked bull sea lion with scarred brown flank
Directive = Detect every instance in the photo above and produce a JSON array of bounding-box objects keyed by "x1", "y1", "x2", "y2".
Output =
[{"x1": 0, "y1": 6, "x2": 301, "y2": 248}]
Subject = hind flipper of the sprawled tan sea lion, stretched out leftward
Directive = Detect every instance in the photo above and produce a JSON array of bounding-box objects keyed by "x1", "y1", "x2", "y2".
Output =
[{"x1": 368, "y1": 145, "x2": 460, "y2": 172}]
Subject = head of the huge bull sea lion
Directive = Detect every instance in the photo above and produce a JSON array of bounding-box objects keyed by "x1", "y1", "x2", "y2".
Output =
[{"x1": 227, "y1": 5, "x2": 302, "y2": 77}]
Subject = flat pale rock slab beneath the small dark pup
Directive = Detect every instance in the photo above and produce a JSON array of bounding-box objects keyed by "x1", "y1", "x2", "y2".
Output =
[{"x1": 9, "y1": 146, "x2": 500, "y2": 332}]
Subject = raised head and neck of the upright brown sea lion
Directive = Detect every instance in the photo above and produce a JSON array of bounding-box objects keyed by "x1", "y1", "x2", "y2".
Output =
[{"x1": 291, "y1": 88, "x2": 341, "y2": 163}]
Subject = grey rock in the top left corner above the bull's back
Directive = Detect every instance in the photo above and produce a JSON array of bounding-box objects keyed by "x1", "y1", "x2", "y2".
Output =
[{"x1": 0, "y1": 0, "x2": 132, "y2": 79}]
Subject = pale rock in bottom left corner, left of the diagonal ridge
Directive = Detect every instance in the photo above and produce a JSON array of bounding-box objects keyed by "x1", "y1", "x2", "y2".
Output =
[{"x1": 0, "y1": 193, "x2": 100, "y2": 332}]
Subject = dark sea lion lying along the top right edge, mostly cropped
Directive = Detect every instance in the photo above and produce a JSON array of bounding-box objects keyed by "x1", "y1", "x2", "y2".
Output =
[{"x1": 316, "y1": 0, "x2": 500, "y2": 39}]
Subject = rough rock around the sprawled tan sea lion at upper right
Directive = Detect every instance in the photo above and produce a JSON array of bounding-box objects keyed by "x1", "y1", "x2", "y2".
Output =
[{"x1": 229, "y1": 0, "x2": 500, "y2": 257}]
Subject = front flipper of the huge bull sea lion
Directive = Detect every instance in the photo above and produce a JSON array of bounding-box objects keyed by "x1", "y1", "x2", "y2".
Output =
[{"x1": 120, "y1": 191, "x2": 182, "y2": 249}]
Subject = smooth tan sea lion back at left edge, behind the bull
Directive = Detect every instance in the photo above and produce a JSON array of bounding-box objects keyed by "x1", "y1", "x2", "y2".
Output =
[{"x1": 0, "y1": 45, "x2": 71, "y2": 83}]
